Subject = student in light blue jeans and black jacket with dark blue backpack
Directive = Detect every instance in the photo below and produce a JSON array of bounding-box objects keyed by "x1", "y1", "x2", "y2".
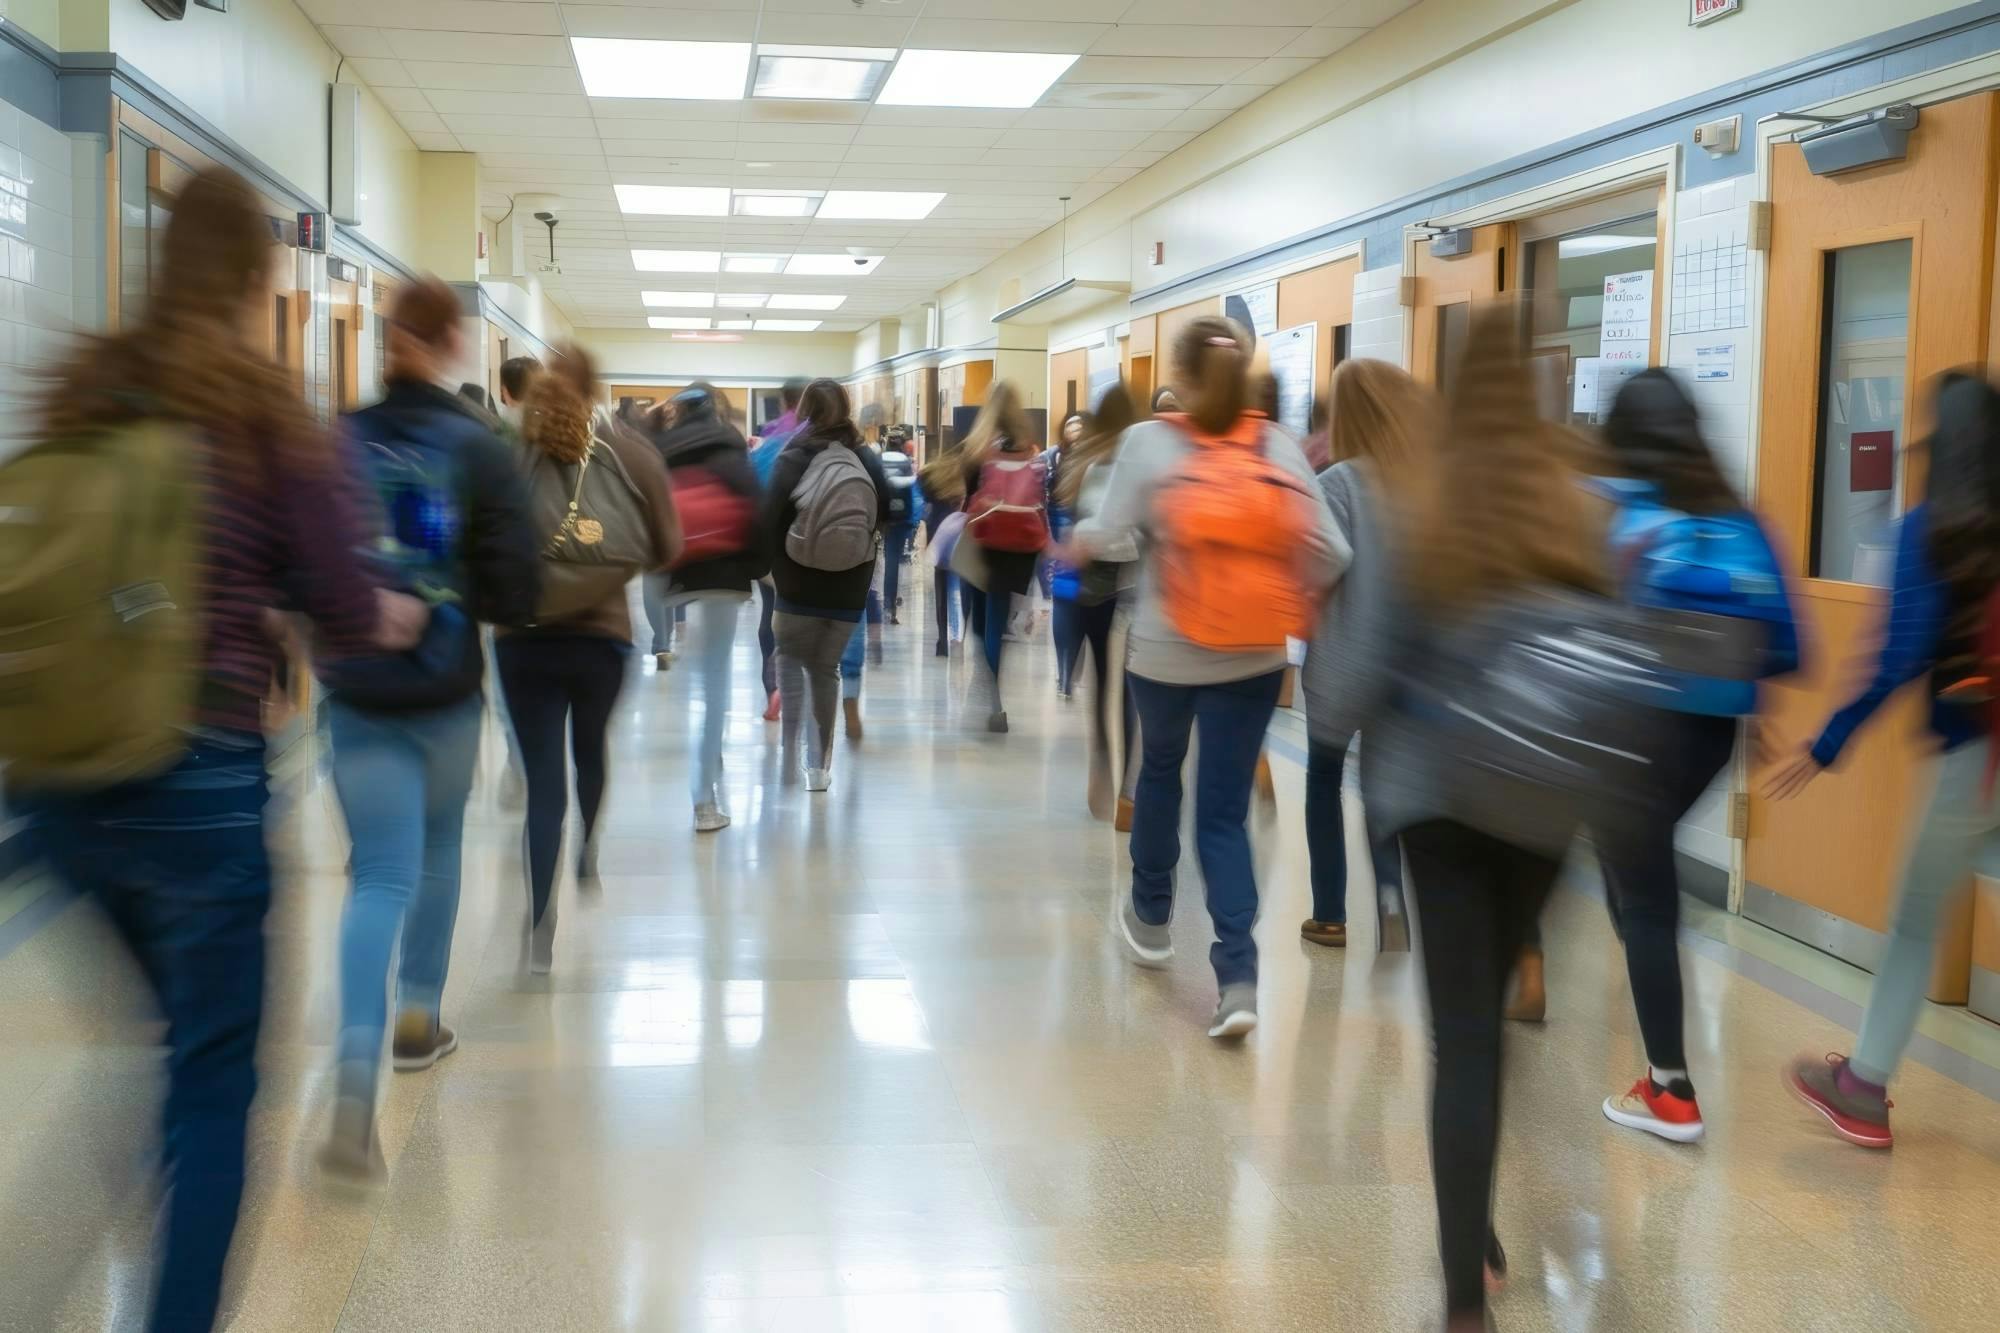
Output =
[{"x1": 320, "y1": 278, "x2": 540, "y2": 1183}]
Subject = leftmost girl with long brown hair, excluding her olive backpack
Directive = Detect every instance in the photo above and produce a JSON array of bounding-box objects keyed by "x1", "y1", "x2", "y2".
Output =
[{"x1": 8, "y1": 168, "x2": 410, "y2": 1333}]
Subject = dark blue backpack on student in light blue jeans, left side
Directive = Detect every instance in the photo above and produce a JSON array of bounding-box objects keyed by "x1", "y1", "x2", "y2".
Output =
[{"x1": 318, "y1": 406, "x2": 486, "y2": 709}]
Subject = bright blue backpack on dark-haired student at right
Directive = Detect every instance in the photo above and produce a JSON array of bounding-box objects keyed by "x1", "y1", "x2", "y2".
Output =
[{"x1": 1596, "y1": 480, "x2": 1798, "y2": 717}]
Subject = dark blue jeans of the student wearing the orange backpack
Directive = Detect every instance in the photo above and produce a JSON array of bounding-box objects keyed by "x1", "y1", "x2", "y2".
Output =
[{"x1": 1126, "y1": 671, "x2": 1284, "y2": 987}]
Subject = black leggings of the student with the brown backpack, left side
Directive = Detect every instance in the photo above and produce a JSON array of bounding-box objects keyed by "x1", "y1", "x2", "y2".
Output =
[{"x1": 498, "y1": 634, "x2": 632, "y2": 921}]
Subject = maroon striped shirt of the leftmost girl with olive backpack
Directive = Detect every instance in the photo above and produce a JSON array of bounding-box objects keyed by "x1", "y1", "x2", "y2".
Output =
[{"x1": 196, "y1": 430, "x2": 376, "y2": 731}]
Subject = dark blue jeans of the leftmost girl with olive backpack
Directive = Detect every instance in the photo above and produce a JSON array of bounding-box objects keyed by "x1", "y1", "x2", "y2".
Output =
[{"x1": 30, "y1": 733, "x2": 270, "y2": 1333}]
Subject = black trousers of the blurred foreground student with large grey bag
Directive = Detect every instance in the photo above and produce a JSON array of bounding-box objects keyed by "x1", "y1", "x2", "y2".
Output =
[{"x1": 1402, "y1": 821, "x2": 1562, "y2": 1315}]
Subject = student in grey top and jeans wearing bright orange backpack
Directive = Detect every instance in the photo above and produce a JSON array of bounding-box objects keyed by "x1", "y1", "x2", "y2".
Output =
[{"x1": 1076, "y1": 318, "x2": 1348, "y2": 1037}]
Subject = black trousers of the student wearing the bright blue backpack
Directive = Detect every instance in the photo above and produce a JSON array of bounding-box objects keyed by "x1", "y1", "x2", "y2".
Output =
[{"x1": 1592, "y1": 715, "x2": 1736, "y2": 1069}]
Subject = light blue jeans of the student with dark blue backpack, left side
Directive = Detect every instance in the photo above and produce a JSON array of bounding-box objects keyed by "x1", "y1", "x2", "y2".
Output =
[{"x1": 326, "y1": 695, "x2": 484, "y2": 1105}]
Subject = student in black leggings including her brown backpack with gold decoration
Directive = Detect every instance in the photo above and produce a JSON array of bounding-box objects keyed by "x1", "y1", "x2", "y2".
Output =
[{"x1": 498, "y1": 346, "x2": 682, "y2": 975}]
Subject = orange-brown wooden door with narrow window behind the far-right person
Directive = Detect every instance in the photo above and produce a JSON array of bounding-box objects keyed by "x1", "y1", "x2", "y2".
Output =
[{"x1": 1744, "y1": 94, "x2": 2000, "y2": 984}]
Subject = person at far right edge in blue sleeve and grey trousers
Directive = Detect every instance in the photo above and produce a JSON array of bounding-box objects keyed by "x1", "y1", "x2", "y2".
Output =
[{"x1": 1766, "y1": 372, "x2": 2000, "y2": 1149}]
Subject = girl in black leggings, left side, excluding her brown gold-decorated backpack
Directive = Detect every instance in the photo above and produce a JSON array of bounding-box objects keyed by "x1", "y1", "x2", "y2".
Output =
[{"x1": 498, "y1": 358, "x2": 682, "y2": 973}]
